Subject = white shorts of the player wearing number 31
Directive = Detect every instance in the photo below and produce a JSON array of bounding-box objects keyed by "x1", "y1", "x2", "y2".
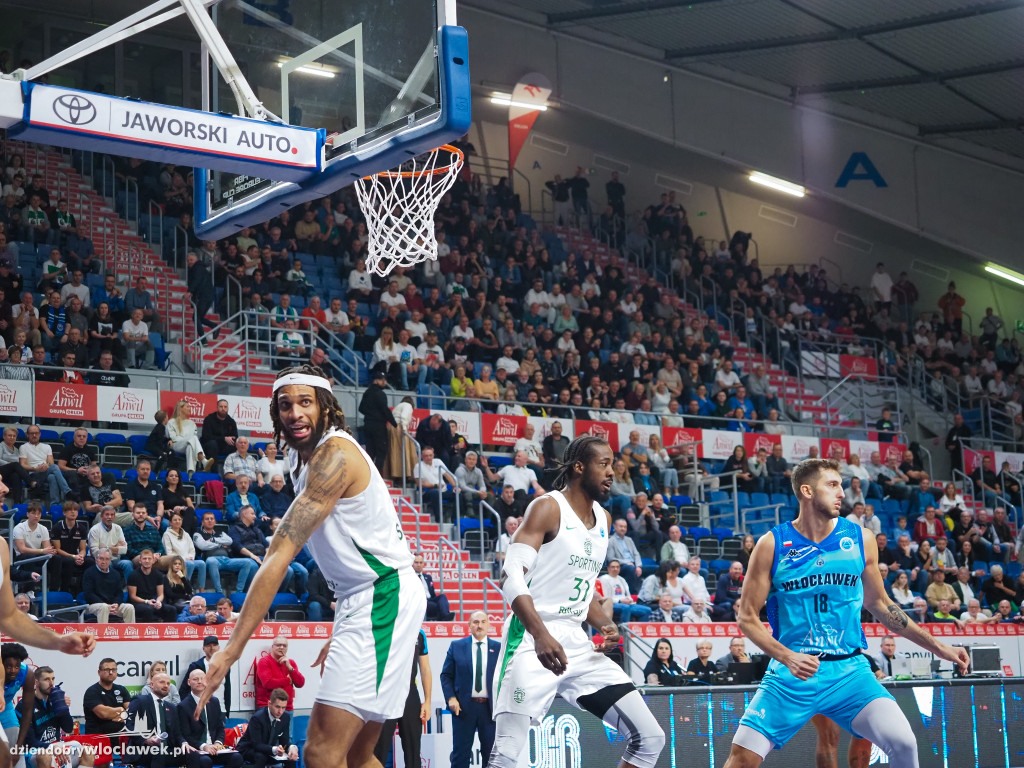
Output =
[{"x1": 494, "y1": 615, "x2": 634, "y2": 725}]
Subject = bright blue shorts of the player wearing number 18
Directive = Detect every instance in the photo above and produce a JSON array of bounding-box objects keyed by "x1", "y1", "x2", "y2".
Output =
[{"x1": 739, "y1": 655, "x2": 892, "y2": 749}]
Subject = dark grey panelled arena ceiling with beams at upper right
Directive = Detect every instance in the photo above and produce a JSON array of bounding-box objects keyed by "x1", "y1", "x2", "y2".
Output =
[{"x1": 463, "y1": 0, "x2": 1024, "y2": 158}]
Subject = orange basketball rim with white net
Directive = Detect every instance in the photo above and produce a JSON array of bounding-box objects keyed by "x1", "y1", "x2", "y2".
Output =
[{"x1": 355, "y1": 144, "x2": 463, "y2": 278}]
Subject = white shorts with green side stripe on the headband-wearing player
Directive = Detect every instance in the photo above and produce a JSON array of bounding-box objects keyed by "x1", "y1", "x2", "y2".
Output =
[{"x1": 316, "y1": 568, "x2": 427, "y2": 723}]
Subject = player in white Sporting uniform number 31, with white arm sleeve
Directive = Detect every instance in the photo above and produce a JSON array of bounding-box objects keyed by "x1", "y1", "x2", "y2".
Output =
[{"x1": 488, "y1": 435, "x2": 665, "y2": 768}]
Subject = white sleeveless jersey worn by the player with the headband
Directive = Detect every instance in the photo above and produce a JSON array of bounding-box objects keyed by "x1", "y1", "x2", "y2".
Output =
[{"x1": 288, "y1": 428, "x2": 413, "y2": 600}]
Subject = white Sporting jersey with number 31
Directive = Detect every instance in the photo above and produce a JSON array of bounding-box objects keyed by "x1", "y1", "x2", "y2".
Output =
[{"x1": 526, "y1": 490, "x2": 608, "y2": 624}]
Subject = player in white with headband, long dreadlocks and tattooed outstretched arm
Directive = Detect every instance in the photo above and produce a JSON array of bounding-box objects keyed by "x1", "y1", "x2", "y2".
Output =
[{"x1": 197, "y1": 365, "x2": 426, "y2": 768}]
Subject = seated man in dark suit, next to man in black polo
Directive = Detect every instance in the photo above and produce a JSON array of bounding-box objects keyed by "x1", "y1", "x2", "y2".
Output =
[{"x1": 126, "y1": 672, "x2": 186, "y2": 768}]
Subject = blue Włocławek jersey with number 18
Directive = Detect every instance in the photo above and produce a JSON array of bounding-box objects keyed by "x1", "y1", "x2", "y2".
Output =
[{"x1": 768, "y1": 517, "x2": 867, "y2": 655}]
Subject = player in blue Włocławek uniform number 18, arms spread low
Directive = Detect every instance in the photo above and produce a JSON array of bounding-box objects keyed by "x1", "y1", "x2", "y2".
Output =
[{"x1": 725, "y1": 459, "x2": 968, "y2": 768}]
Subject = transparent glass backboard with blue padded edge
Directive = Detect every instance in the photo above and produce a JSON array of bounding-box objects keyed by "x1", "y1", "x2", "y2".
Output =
[{"x1": 195, "y1": 0, "x2": 470, "y2": 239}]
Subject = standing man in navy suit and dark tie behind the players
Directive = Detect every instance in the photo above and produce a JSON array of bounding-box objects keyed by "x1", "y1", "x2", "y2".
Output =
[{"x1": 441, "y1": 610, "x2": 501, "y2": 768}]
